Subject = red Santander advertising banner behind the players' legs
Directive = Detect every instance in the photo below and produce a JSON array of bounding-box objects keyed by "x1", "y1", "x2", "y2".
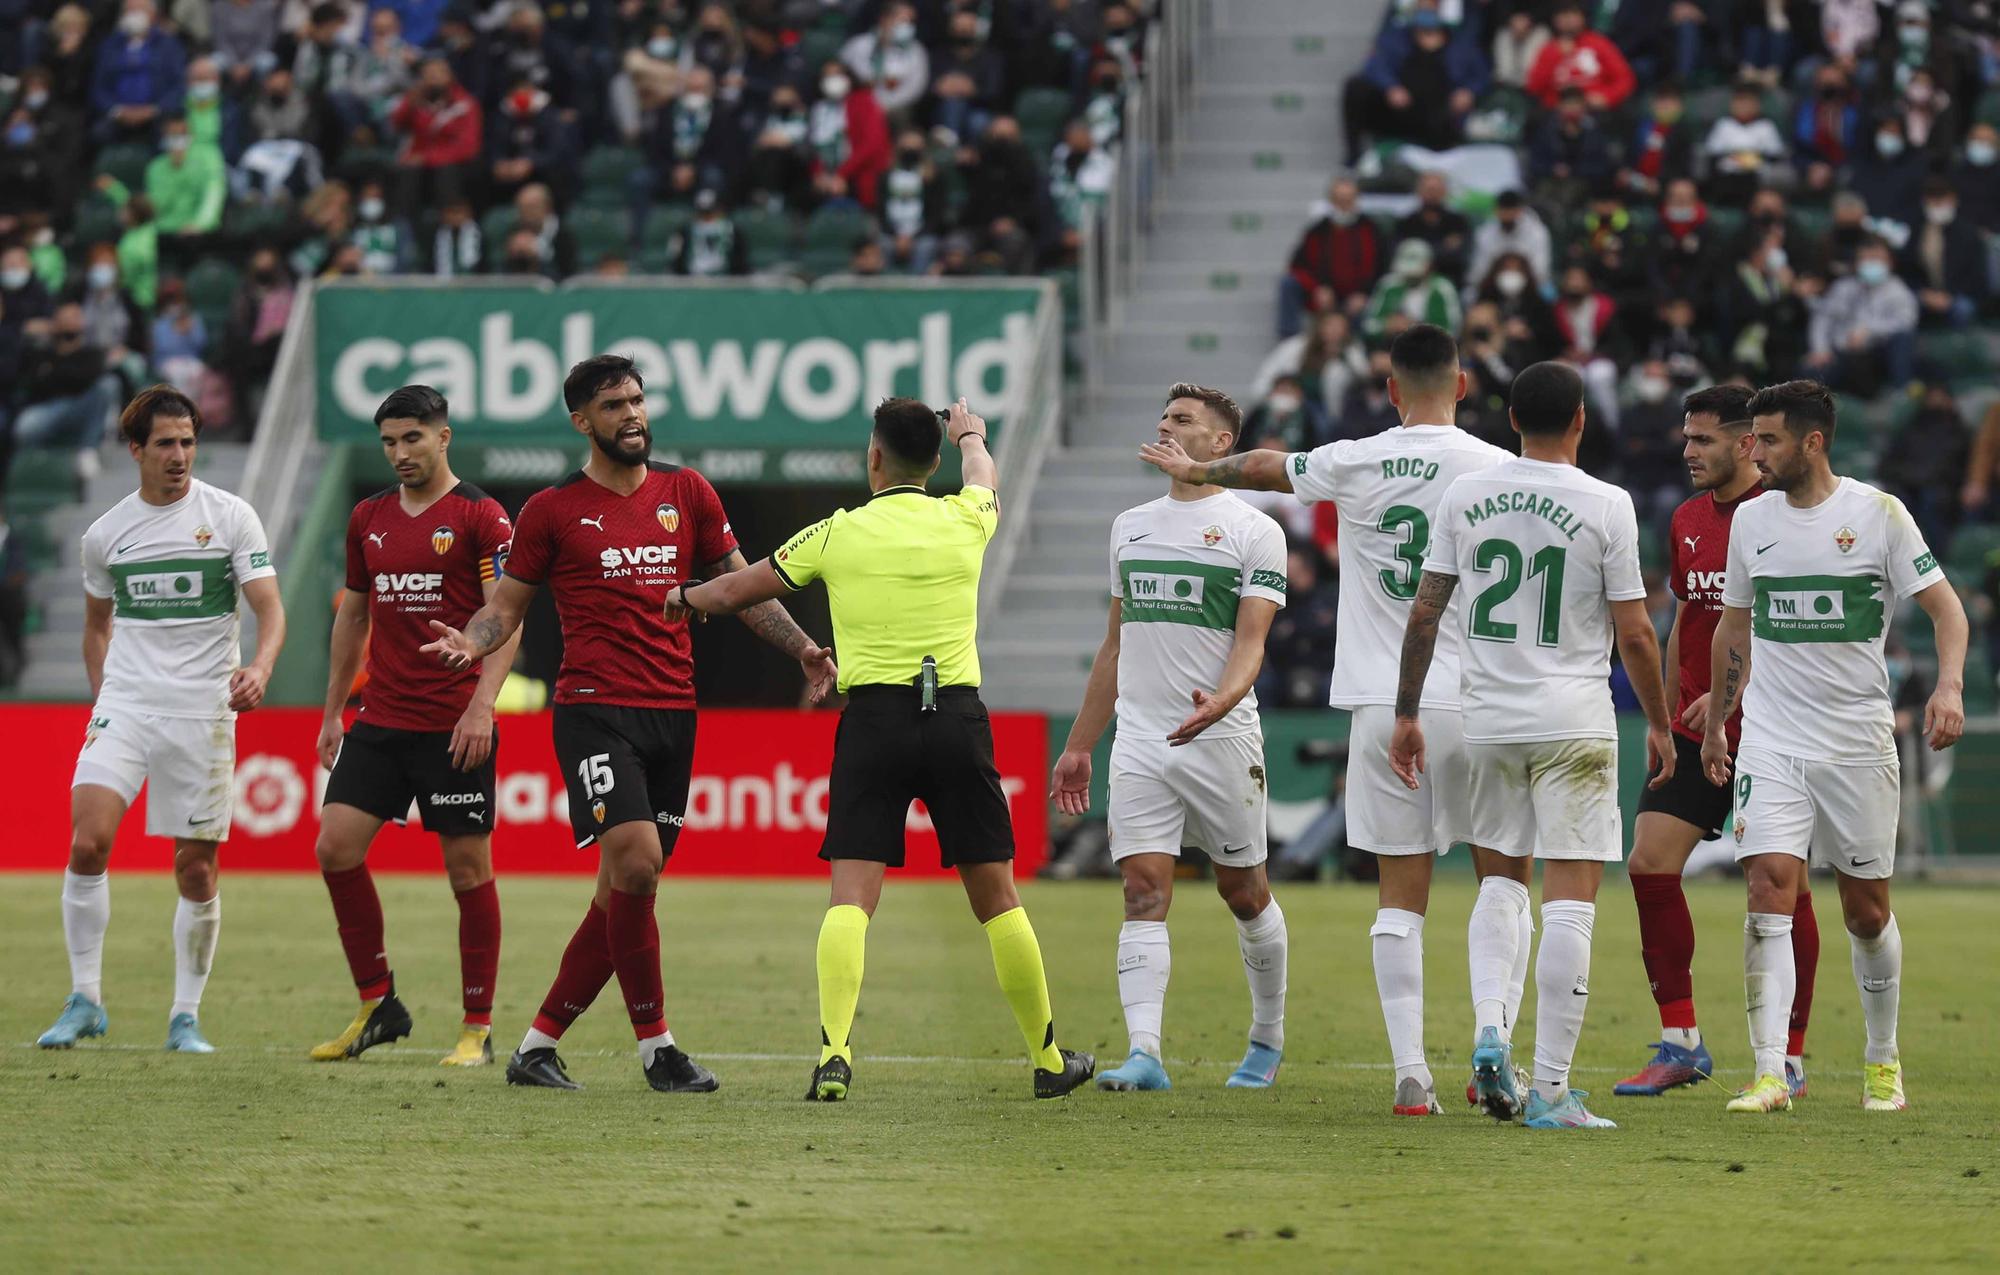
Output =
[{"x1": 0, "y1": 703, "x2": 1048, "y2": 877}]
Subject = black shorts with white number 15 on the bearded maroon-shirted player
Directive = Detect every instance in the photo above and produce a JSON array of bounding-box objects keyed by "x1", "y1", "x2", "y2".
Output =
[{"x1": 554, "y1": 703, "x2": 694, "y2": 855}]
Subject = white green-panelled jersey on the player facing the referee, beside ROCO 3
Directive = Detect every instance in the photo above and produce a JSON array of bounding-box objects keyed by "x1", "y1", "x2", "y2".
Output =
[{"x1": 1112, "y1": 492, "x2": 1286, "y2": 739}]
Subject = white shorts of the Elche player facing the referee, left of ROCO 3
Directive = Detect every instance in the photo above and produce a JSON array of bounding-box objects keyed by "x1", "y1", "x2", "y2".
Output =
[{"x1": 1110, "y1": 733, "x2": 1270, "y2": 867}]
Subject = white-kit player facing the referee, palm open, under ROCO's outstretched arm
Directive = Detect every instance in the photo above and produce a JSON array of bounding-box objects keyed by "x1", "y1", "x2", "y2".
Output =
[{"x1": 1050, "y1": 386, "x2": 1288, "y2": 1089}]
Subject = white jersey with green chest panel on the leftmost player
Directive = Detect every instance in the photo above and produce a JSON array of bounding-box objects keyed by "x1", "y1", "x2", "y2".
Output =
[{"x1": 82, "y1": 480, "x2": 278, "y2": 717}]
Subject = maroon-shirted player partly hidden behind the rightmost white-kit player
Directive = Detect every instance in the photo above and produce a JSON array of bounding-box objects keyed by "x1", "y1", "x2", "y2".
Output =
[{"x1": 1612, "y1": 386, "x2": 1820, "y2": 1097}]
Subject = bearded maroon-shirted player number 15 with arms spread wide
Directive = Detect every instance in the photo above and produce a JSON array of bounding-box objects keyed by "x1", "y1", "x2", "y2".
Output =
[{"x1": 422, "y1": 354, "x2": 838, "y2": 1093}]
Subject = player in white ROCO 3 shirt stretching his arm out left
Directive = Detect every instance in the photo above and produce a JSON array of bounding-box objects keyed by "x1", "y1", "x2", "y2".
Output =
[{"x1": 1146, "y1": 324, "x2": 1532, "y2": 1115}]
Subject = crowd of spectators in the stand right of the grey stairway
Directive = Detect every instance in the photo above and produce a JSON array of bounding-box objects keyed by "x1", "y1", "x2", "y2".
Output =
[{"x1": 1244, "y1": 0, "x2": 2000, "y2": 705}]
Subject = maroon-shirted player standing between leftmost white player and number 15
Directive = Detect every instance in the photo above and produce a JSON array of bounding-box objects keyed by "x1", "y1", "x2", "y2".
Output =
[{"x1": 312, "y1": 386, "x2": 518, "y2": 1067}]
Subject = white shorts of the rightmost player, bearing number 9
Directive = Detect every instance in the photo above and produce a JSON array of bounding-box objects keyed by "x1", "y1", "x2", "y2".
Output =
[{"x1": 1730, "y1": 747, "x2": 1902, "y2": 881}]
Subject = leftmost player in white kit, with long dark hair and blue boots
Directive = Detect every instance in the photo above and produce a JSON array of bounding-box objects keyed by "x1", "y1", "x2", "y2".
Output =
[{"x1": 38, "y1": 386, "x2": 284, "y2": 1053}]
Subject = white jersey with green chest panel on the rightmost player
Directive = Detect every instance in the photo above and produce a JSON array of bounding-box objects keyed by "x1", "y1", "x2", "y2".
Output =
[{"x1": 1722, "y1": 478, "x2": 1944, "y2": 765}]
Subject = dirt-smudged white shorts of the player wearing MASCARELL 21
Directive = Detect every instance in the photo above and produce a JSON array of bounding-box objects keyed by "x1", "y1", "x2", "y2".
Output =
[{"x1": 1466, "y1": 739, "x2": 1624, "y2": 863}]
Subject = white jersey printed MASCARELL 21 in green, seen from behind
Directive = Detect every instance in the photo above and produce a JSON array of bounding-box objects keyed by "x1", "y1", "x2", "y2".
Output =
[{"x1": 1424, "y1": 458, "x2": 1646, "y2": 743}]
